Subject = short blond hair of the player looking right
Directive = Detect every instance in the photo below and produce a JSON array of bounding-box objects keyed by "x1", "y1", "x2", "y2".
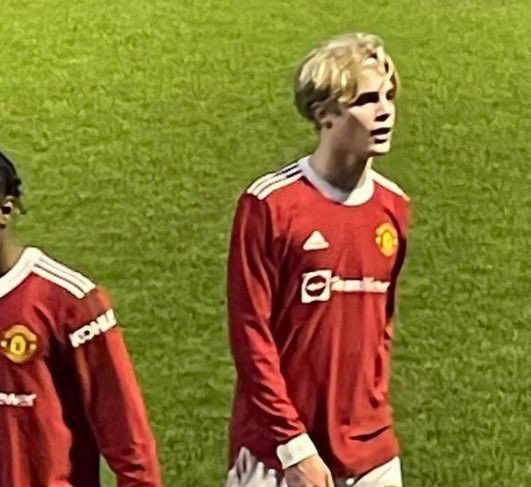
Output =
[{"x1": 294, "y1": 32, "x2": 399, "y2": 120}]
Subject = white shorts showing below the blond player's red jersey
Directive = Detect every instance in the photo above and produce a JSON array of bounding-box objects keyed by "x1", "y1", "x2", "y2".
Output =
[{"x1": 225, "y1": 448, "x2": 403, "y2": 487}]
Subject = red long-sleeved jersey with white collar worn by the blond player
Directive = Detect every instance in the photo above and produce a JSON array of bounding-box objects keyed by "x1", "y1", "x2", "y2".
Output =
[{"x1": 228, "y1": 157, "x2": 409, "y2": 477}]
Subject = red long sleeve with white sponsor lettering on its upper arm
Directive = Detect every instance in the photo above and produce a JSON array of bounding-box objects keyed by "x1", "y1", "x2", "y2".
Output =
[{"x1": 58, "y1": 288, "x2": 162, "y2": 487}]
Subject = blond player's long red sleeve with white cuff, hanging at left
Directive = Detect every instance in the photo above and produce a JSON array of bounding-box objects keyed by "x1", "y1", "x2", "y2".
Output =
[{"x1": 228, "y1": 194, "x2": 313, "y2": 463}]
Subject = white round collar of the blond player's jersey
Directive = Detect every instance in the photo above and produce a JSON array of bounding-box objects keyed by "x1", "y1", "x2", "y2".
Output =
[{"x1": 299, "y1": 156, "x2": 374, "y2": 206}]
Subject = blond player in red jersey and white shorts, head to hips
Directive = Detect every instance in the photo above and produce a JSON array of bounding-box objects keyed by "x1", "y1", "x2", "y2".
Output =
[{"x1": 226, "y1": 33, "x2": 408, "y2": 487}]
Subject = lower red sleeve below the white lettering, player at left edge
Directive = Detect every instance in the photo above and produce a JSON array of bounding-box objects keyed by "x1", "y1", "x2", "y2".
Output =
[{"x1": 75, "y1": 329, "x2": 162, "y2": 487}]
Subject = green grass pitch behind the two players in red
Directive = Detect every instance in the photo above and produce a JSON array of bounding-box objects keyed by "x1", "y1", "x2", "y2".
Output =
[{"x1": 0, "y1": 0, "x2": 531, "y2": 487}]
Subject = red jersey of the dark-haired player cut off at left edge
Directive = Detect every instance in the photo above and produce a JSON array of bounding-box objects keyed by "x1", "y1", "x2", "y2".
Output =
[{"x1": 0, "y1": 248, "x2": 162, "y2": 487}]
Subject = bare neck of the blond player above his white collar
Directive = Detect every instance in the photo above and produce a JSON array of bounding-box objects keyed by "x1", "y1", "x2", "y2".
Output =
[{"x1": 310, "y1": 144, "x2": 370, "y2": 191}]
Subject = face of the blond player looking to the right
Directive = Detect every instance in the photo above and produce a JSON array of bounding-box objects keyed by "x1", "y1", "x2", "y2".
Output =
[{"x1": 324, "y1": 69, "x2": 396, "y2": 158}]
